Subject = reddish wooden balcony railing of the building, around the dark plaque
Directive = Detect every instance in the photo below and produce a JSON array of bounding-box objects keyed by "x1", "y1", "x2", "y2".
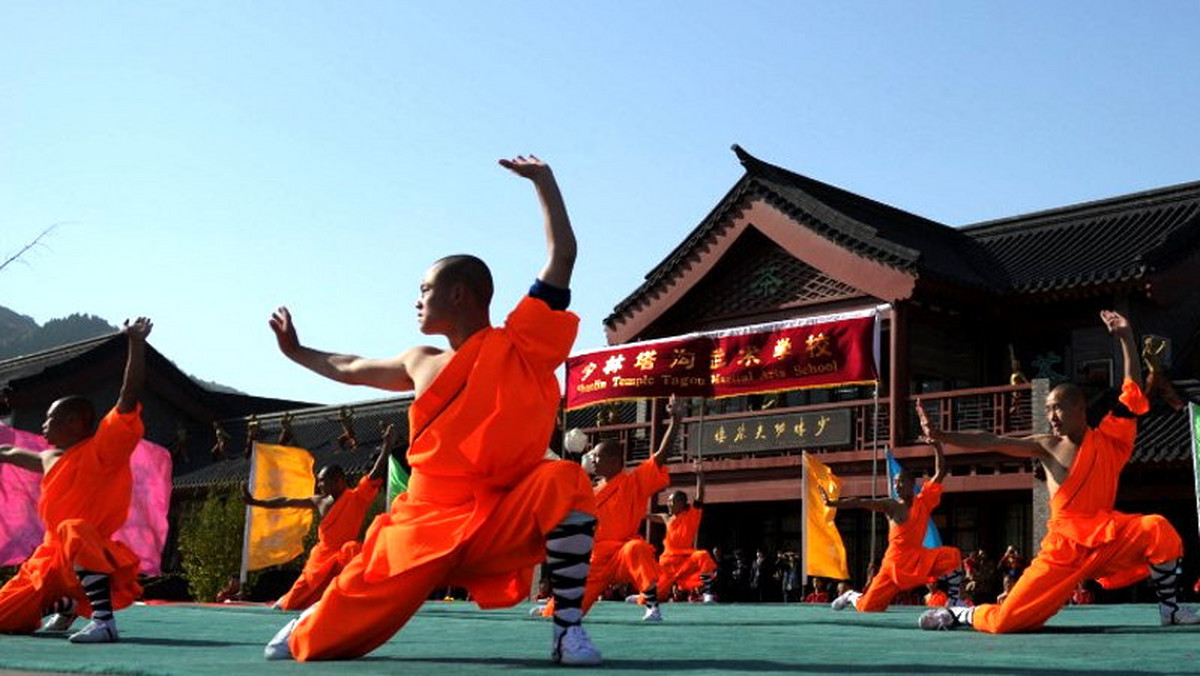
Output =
[{"x1": 566, "y1": 384, "x2": 1033, "y2": 463}]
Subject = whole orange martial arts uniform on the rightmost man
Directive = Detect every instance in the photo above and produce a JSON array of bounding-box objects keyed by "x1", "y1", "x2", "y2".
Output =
[{"x1": 972, "y1": 378, "x2": 1183, "y2": 634}]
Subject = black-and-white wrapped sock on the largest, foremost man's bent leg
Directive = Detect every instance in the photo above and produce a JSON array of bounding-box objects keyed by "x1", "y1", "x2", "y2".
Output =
[{"x1": 546, "y1": 512, "x2": 596, "y2": 635}]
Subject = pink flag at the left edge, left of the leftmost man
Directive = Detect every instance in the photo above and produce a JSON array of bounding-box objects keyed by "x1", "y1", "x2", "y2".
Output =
[{"x1": 0, "y1": 423, "x2": 49, "y2": 566}]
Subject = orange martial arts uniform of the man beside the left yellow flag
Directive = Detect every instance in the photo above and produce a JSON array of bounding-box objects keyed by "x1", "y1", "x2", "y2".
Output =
[{"x1": 278, "y1": 477, "x2": 383, "y2": 610}]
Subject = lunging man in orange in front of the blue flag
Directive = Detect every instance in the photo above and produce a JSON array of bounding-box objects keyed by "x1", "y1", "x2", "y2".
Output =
[{"x1": 822, "y1": 439, "x2": 962, "y2": 612}]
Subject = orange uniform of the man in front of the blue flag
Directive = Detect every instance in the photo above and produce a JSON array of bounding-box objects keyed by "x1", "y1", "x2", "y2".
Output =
[{"x1": 854, "y1": 481, "x2": 962, "y2": 612}]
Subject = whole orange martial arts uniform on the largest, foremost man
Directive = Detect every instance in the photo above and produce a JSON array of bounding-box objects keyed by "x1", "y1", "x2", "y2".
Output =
[{"x1": 288, "y1": 297, "x2": 595, "y2": 660}]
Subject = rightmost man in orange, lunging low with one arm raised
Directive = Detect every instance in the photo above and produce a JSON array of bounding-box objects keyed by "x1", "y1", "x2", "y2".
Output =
[{"x1": 918, "y1": 310, "x2": 1200, "y2": 634}]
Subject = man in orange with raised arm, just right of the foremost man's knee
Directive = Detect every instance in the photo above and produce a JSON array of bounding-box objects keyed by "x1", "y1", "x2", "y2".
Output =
[{"x1": 542, "y1": 395, "x2": 682, "y2": 622}]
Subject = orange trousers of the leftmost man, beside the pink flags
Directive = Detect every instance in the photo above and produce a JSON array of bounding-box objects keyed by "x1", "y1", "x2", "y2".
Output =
[{"x1": 0, "y1": 519, "x2": 142, "y2": 634}]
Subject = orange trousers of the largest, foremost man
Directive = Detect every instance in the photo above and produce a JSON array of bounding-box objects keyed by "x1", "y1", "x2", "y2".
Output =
[{"x1": 288, "y1": 462, "x2": 594, "y2": 660}]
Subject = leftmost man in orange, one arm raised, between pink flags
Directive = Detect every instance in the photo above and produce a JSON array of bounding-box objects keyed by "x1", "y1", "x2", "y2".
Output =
[{"x1": 0, "y1": 317, "x2": 152, "y2": 644}]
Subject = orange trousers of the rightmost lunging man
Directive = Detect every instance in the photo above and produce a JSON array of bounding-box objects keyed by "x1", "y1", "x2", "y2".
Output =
[{"x1": 972, "y1": 514, "x2": 1183, "y2": 634}]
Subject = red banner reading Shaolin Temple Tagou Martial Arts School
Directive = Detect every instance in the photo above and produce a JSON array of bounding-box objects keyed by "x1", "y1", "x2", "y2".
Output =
[{"x1": 566, "y1": 310, "x2": 878, "y2": 409}]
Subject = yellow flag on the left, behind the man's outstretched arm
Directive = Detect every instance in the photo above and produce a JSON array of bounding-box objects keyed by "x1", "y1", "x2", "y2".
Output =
[{"x1": 245, "y1": 443, "x2": 316, "y2": 570}]
